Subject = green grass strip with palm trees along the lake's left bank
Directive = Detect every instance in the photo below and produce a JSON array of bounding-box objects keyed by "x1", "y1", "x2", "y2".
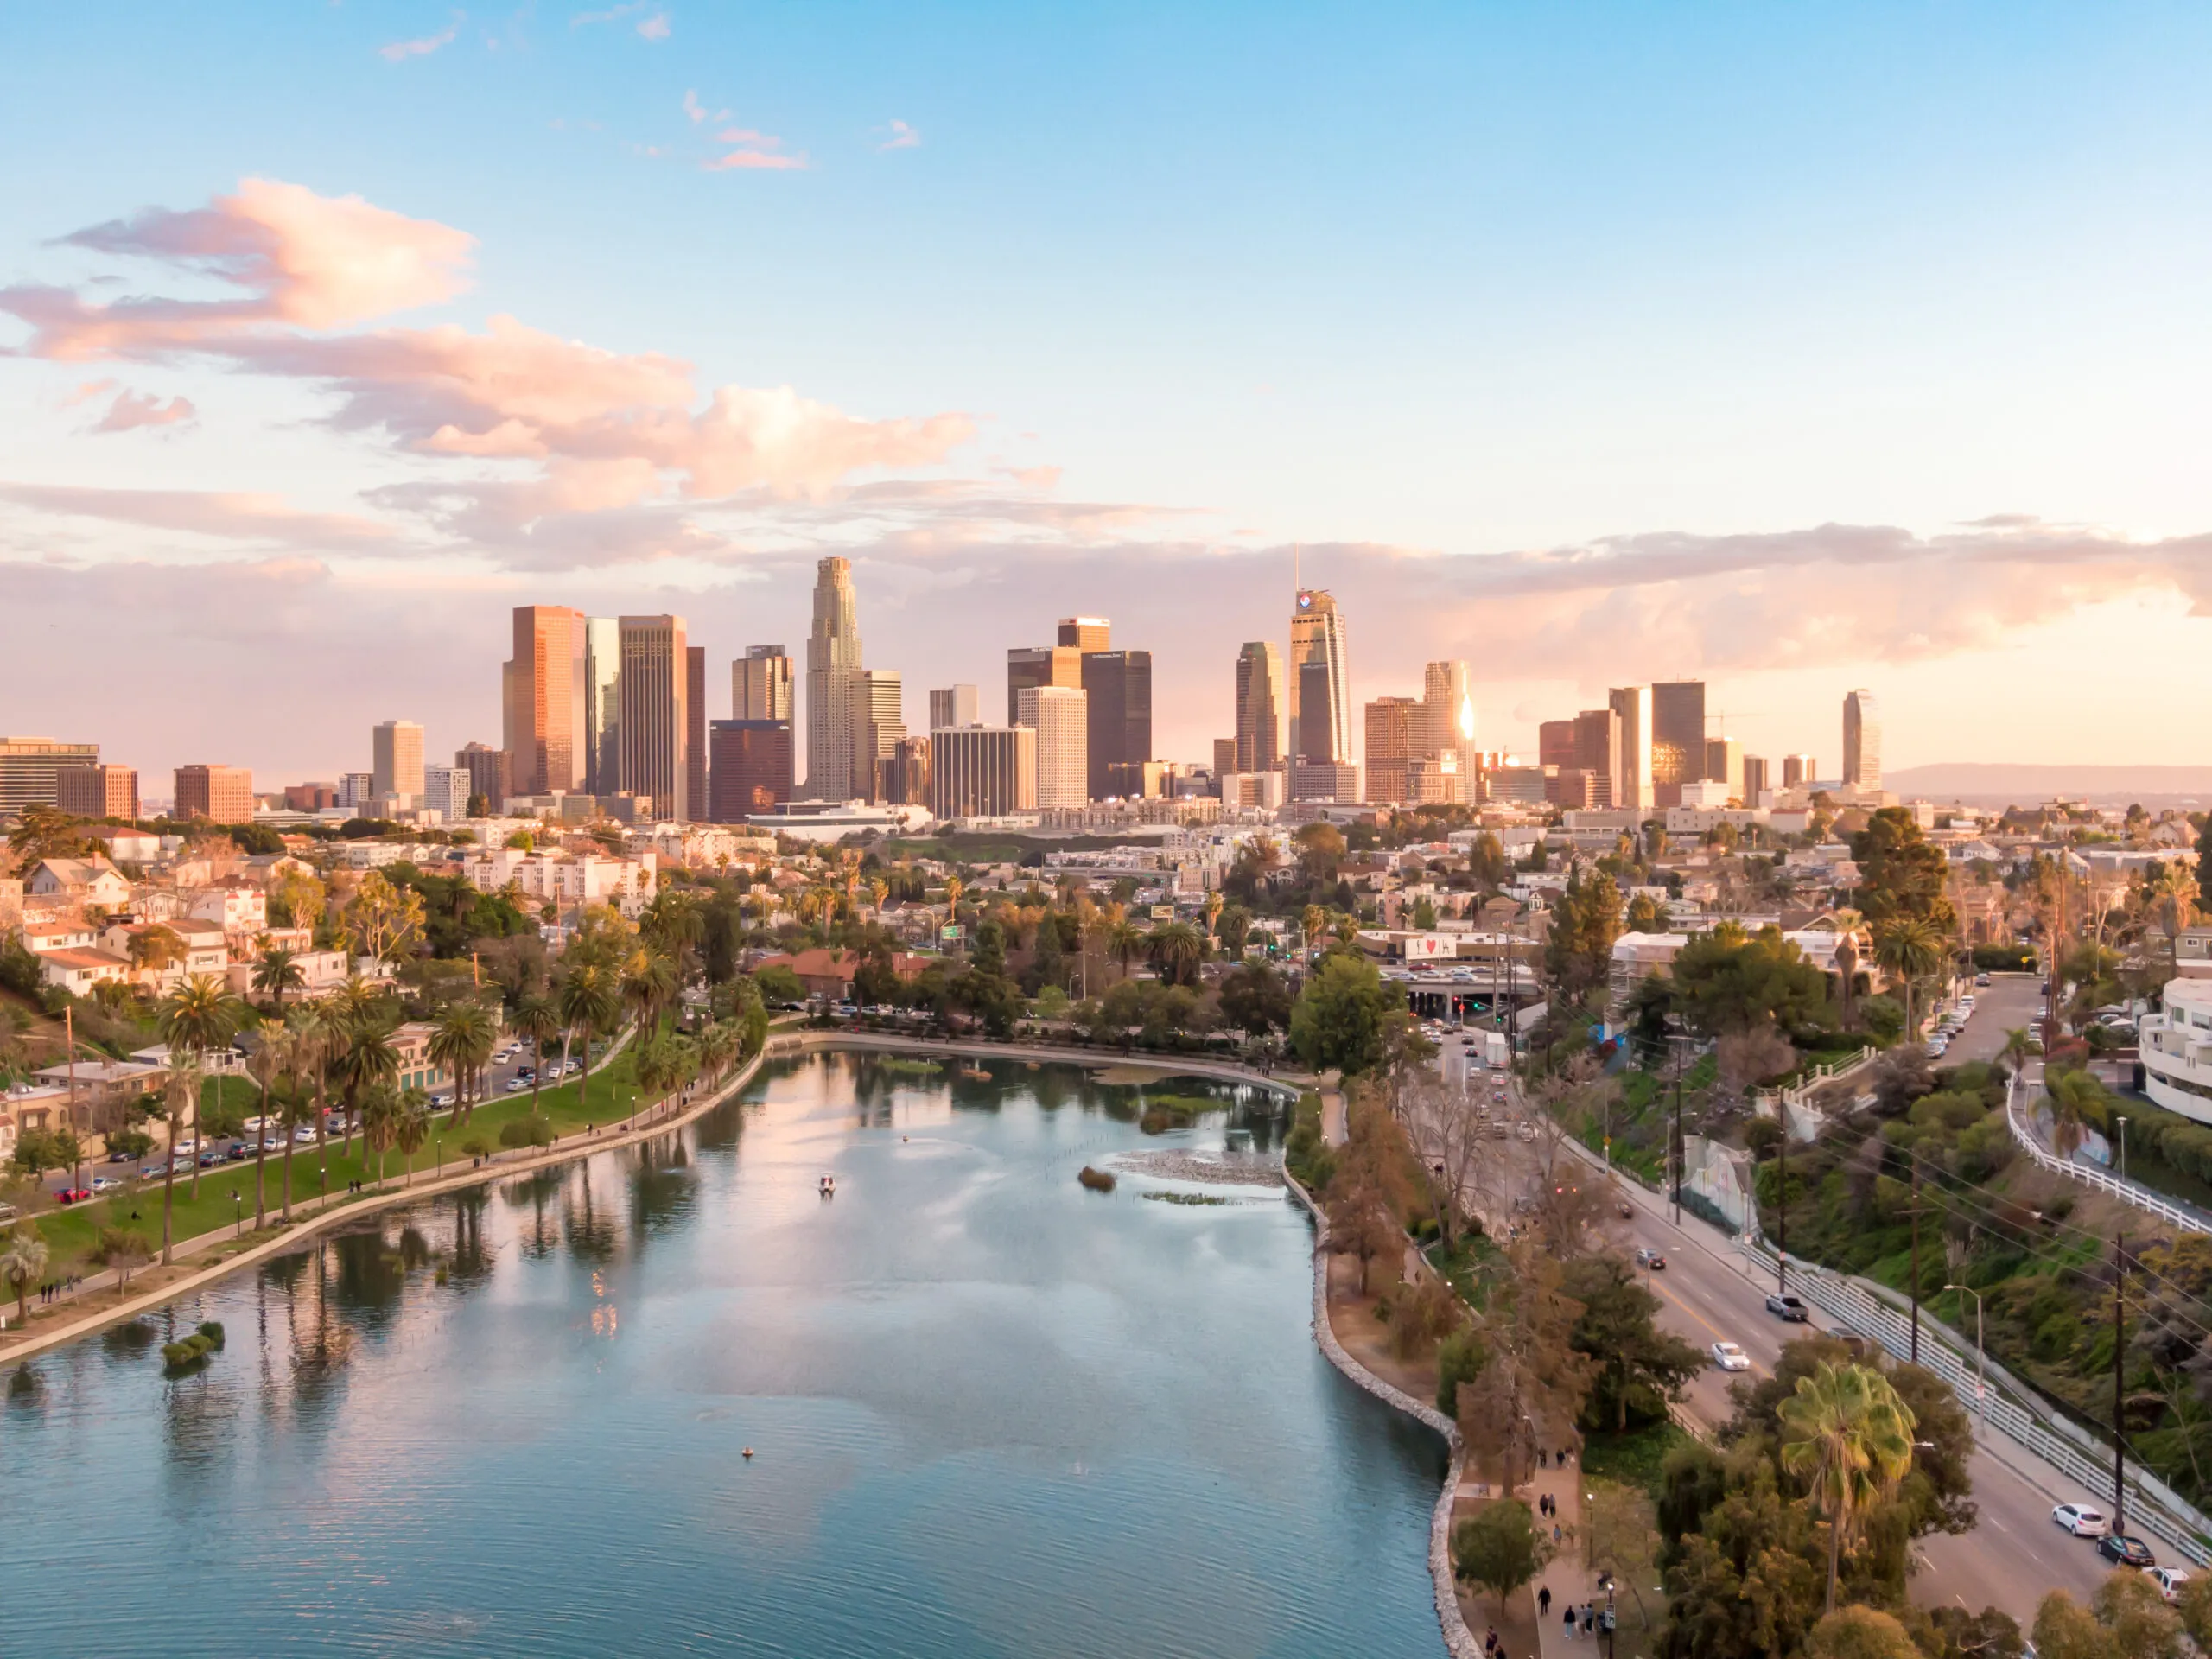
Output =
[{"x1": 38, "y1": 1044, "x2": 637, "y2": 1274}]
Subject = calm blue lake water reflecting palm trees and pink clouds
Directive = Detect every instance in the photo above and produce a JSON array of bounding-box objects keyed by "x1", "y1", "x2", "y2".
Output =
[{"x1": 0, "y1": 1055, "x2": 1442, "y2": 1659}]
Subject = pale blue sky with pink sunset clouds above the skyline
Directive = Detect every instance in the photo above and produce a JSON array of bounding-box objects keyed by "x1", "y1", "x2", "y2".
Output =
[{"x1": 0, "y1": 0, "x2": 2212, "y2": 794}]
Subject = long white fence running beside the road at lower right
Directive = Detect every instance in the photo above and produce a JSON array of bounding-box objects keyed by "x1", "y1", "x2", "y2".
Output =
[{"x1": 1747, "y1": 1239, "x2": 2212, "y2": 1566}]
